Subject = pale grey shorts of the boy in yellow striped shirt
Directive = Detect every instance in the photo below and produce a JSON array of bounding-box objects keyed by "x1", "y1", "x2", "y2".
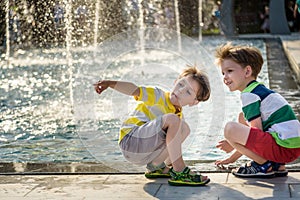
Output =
[{"x1": 119, "y1": 117, "x2": 166, "y2": 165}]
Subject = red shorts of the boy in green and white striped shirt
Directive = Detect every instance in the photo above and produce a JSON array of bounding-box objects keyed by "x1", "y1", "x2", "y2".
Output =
[{"x1": 246, "y1": 127, "x2": 300, "y2": 163}]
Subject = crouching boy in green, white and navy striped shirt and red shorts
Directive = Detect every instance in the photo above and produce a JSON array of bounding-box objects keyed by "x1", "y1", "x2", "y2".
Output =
[{"x1": 215, "y1": 43, "x2": 300, "y2": 177}]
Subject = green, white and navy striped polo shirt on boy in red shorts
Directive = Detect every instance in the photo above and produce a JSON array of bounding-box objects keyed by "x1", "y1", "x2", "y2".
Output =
[{"x1": 241, "y1": 81, "x2": 300, "y2": 148}]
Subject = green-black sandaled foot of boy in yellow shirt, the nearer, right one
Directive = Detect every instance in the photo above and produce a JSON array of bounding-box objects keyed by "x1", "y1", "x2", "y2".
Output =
[{"x1": 168, "y1": 167, "x2": 210, "y2": 186}]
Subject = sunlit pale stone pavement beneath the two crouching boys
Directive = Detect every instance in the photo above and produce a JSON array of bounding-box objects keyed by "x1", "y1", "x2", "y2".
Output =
[{"x1": 0, "y1": 172, "x2": 300, "y2": 200}]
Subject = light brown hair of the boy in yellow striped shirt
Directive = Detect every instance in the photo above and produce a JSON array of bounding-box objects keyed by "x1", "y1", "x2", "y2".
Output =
[{"x1": 179, "y1": 65, "x2": 210, "y2": 101}]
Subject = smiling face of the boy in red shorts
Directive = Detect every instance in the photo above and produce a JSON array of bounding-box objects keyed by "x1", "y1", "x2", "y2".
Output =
[{"x1": 221, "y1": 59, "x2": 253, "y2": 91}]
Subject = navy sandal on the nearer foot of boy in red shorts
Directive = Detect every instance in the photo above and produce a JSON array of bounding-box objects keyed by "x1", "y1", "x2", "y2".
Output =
[{"x1": 232, "y1": 161, "x2": 275, "y2": 178}]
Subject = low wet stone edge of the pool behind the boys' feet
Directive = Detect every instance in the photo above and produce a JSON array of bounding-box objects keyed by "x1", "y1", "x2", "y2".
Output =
[{"x1": 0, "y1": 159, "x2": 300, "y2": 175}]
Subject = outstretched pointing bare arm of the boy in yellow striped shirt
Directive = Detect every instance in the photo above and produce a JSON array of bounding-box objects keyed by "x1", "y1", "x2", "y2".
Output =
[{"x1": 94, "y1": 80, "x2": 140, "y2": 96}]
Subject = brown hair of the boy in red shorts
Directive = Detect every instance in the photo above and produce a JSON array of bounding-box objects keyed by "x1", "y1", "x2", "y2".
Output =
[{"x1": 215, "y1": 43, "x2": 264, "y2": 79}]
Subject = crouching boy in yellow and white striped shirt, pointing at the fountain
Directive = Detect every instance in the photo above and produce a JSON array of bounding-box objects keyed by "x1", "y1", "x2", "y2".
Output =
[{"x1": 94, "y1": 67, "x2": 210, "y2": 186}]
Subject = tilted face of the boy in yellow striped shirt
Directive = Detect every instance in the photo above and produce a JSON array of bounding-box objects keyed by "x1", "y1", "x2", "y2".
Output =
[{"x1": 170, "y1": 76, "x2": 200, "y2": 107}]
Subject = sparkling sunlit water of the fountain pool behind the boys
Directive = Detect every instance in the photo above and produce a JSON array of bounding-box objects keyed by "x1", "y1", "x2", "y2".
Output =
[{"x1": 0, "y1": 28, "x2": 268, "y2": 172}]
